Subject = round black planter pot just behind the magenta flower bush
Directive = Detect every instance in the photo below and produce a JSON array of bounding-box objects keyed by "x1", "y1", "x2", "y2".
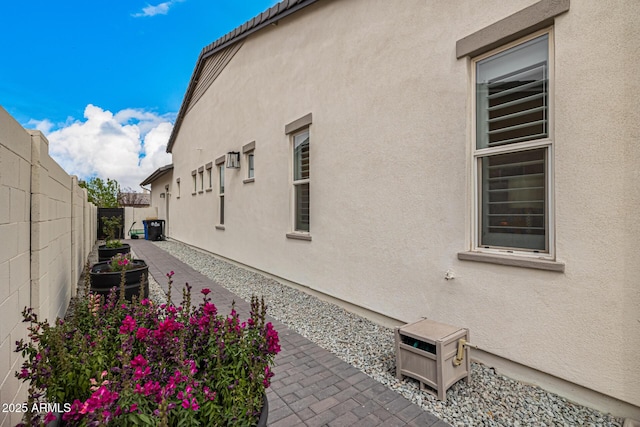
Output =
[{"x1": 89, "y1": 259, "x2": 149, "y2": 301}]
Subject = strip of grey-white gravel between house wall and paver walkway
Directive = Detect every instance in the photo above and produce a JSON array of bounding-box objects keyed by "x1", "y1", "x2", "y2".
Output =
[{"x1": 154, "y1": 241, "x2": 623, "y2": 426}]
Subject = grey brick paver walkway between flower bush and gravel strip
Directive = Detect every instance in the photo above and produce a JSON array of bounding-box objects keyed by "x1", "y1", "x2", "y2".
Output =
[{"x1": 127, "y1": 240, "x2": 449, "y2": 427}]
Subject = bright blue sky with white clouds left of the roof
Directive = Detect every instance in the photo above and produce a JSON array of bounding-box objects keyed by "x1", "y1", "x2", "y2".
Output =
[{"x1": 0, "y1": 0, "x2": 277, "y2": 190}]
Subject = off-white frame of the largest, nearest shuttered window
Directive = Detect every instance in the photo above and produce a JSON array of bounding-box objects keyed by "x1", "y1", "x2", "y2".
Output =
[{"x1": 471, "y1": 28, "x2": 555, "y2": 260}]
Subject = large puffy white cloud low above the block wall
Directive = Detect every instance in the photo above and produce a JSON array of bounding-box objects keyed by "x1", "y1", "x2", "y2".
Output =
[{"x1": 41, "y1": 104, "x2": 173, "y2": 190}]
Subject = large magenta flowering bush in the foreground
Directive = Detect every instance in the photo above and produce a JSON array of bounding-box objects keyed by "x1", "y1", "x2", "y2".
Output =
[{"x1": 16, "y1": 274, "x2": 280, "y2": 426}]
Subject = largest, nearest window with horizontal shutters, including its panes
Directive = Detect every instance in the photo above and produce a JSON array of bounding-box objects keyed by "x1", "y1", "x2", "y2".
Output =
[{"x1": 474, "y1": 32, "x2": 552, "y2": 253}]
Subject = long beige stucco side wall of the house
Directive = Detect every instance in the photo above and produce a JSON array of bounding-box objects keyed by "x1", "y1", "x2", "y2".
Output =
[{"x1": 168, "y1": 0, "x2": 640, "y2": 418}]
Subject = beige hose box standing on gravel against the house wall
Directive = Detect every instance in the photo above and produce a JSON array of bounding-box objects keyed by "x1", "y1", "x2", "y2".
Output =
[{"x1": 395, "y1": 319, "x2": 471, "y2": 400}]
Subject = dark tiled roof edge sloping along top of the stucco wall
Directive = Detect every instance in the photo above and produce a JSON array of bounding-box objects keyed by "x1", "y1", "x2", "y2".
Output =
[{"x1": 166, "y1": 0, "x2": 318, "y2": 154}]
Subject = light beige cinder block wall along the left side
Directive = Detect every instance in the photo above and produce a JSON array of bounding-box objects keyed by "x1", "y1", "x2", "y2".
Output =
[{"x1": 0, "y1": 107, "x2": 97, "y2": 426}]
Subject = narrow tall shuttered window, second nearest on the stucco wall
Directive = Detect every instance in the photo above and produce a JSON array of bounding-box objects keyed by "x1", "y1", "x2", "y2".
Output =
[{"x1": 293, "y1": 129, "x2": 310, "y2": 232}]
